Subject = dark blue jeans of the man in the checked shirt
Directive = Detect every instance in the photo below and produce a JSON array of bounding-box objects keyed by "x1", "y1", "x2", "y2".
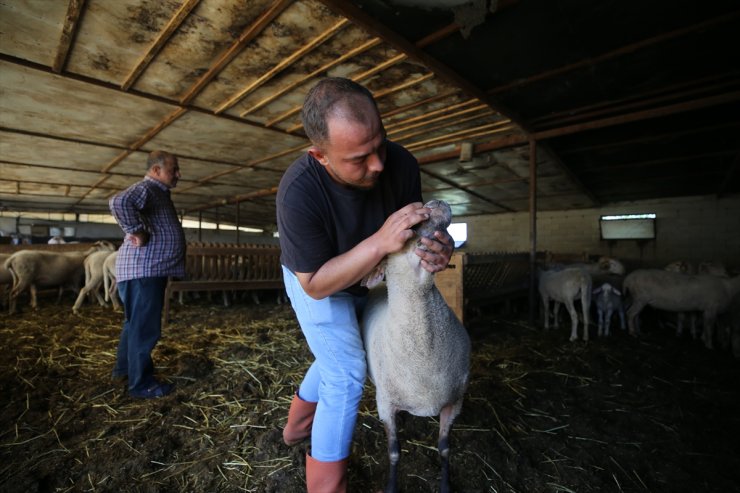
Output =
[{"x1": 113, "y1": 277, "x2": 167, "y2": 390}]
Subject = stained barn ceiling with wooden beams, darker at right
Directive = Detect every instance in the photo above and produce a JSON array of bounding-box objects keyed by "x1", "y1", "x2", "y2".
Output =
[{"x1": 0, "y1": 0, "x2": 740, "y2": 261}]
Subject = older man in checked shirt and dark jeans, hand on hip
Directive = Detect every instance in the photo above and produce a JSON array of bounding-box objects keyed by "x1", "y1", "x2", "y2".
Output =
[{"x1": 109, "y1": 151, "x2": 185, "y2": 399}]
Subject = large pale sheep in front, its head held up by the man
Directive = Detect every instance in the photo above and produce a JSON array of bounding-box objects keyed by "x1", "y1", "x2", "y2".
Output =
[{"x1": 362, "y1": 200, "x2": 470, "y2": 493}]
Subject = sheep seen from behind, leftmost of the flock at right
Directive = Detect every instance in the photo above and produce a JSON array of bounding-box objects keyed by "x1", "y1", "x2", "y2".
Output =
[{"x1": 539, "y1": 267, "x2": 591, "y2": 341}]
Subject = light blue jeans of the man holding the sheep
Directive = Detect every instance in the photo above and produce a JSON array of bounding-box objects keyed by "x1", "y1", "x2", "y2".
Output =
[{"x1": 283, "y1": 267, "x2": 367, "y2": 462}]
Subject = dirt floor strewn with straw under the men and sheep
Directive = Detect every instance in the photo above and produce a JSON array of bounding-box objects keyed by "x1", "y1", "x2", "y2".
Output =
[{"x1": 0, "y1": 292, "x2": 740, "y2": 493}]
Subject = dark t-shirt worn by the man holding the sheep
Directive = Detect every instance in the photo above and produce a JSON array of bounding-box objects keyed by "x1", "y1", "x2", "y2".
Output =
[{"x1": 276, "y1": 141, "x2": 422, "y2": 294}]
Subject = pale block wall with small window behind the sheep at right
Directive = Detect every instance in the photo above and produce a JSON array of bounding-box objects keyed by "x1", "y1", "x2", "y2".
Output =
[{"x1": 453, "y1": 195, "x2": 740, "y2": 270}]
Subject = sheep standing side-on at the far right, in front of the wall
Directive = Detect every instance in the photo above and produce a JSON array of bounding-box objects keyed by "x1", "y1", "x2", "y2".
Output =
[{"x1": 623, "y1": 269, "x2": 740, "y2": 349}]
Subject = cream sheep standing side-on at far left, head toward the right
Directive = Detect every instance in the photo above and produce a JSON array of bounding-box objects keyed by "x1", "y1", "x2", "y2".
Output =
[{"x1": 4, "y1": 241, "x2": 115, "y2": 313}]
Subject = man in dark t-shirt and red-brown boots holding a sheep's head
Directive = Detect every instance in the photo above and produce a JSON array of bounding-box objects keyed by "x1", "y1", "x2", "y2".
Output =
[{"x1": 276, "y1": 78, "x2": 453, "y2": 493}]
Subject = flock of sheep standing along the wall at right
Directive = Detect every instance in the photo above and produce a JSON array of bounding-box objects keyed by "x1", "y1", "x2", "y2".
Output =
[{"x1": 538, "y1": 257, "x2": 740, "y2": 358}]
